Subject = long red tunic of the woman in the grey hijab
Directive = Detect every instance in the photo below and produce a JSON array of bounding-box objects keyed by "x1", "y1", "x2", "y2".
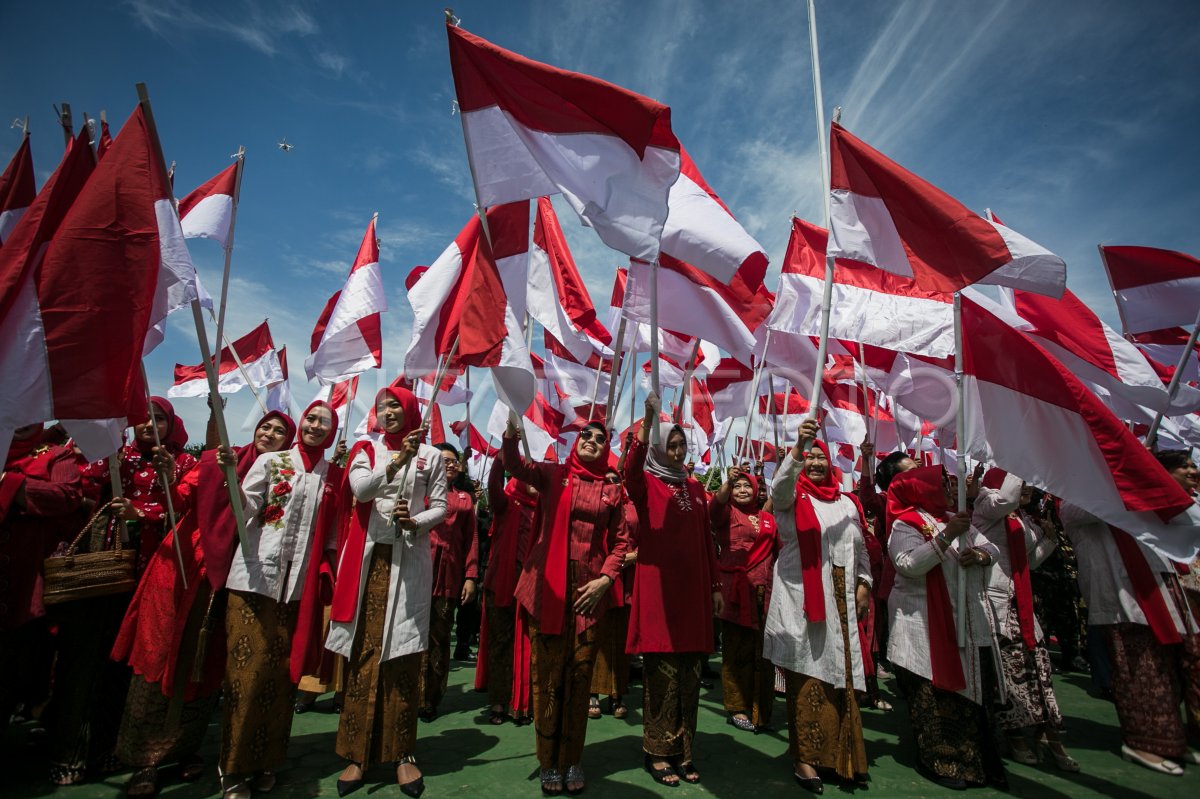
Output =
[{"x1": 625, "y1": 439, "x2": 720, "y2": 654}]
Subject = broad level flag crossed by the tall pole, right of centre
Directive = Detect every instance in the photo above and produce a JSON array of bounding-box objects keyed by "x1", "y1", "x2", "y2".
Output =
[{"x1": 767, "y1": 218, "x2": 954, "y2": 360}]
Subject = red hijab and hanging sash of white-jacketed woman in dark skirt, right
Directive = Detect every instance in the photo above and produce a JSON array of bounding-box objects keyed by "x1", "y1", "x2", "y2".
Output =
[{"x1": 887, "y1": 465, "x2": 967, "y2": 691}]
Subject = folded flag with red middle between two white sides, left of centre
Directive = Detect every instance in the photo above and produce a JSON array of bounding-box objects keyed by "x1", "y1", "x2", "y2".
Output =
[{"x1": 404, "y1": 202, "x2": 534, "y2": 410}]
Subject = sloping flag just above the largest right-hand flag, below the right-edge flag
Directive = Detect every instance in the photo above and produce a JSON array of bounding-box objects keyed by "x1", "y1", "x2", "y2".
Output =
[{"x1": 993, "y1": 289, "x2": 1200, "y2": 419}]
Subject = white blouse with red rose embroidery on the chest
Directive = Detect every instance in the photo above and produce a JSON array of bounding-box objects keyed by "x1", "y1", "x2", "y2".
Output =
[{"x1": 227, "y1": 446, "x2": 336, "y2": 602}]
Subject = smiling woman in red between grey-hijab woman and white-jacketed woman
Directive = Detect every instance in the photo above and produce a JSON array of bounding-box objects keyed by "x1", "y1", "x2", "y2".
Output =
[{"x1": 709, "y1": 467, "x2": 779, "y2": 732}]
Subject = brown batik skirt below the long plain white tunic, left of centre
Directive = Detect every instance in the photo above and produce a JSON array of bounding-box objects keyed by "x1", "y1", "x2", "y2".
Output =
[{"x1": 335, "y1": 545, "x2": 421, "y2": 769}]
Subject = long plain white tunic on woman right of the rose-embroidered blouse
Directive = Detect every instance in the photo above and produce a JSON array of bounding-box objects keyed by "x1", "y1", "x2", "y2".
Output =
[{"x1": 325, "y1": 441, "x2": 446, "y2": 661}]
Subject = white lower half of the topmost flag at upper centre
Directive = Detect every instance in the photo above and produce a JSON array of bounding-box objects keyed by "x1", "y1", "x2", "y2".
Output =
[{"x1": 462, "y1": 106, "x2": 679, "y2": 262}]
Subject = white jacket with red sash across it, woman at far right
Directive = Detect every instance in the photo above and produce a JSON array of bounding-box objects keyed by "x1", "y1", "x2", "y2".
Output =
[{"x1": 1060, "y1": 503, "x2": 1195, "y2": 635}]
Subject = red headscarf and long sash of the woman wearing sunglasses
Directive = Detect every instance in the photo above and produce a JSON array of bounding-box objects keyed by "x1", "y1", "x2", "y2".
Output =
[{"x1": 539, "y1": 425, "x2": 608, "y2": 636}]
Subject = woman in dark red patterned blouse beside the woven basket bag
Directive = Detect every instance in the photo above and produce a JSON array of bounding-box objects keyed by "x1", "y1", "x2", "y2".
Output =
[{"x1": 44, "y1": 397, "x2": 196, "y2": 785}]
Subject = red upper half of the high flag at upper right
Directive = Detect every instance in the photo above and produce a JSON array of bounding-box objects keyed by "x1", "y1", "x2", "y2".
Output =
[{"x1": 829, "y1": 122, "x2": 1013, "y2": 293}]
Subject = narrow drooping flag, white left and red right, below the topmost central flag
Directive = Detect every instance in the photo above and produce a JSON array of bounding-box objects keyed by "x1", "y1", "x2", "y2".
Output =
[{"x1": 530, "y1": 197, "x2": 612, "y2": 362}]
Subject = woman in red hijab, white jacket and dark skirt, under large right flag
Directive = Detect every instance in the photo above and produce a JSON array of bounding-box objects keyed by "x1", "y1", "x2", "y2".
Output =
[{"x1": 887, "y1": 467, "x2": 1007, "y2": 789}]
